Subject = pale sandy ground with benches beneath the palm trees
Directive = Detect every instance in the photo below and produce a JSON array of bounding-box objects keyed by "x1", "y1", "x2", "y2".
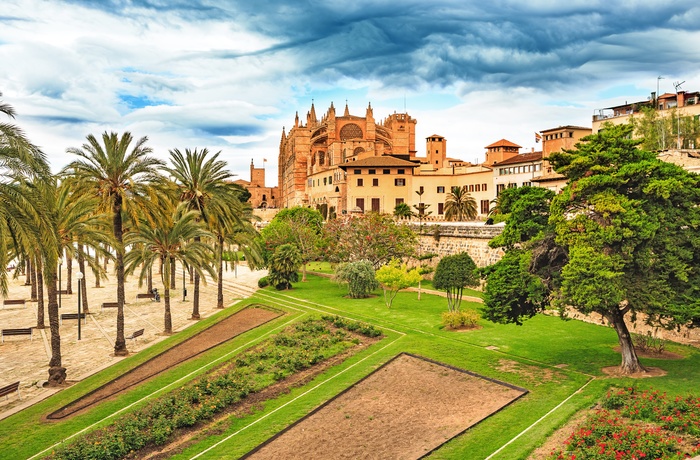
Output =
[{"x1": 0, "y1": 264, "x2": 266, "y2": 419}]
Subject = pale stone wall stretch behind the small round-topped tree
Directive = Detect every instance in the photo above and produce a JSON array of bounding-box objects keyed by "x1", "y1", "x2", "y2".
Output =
[{"x1": 409, "y1": 222, "x2": 504, "y2": 267}]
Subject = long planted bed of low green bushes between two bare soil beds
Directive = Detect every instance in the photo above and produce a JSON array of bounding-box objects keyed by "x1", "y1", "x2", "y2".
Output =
[{"x1": 48, "y1": 317, "x2": 381, "y2": 460}]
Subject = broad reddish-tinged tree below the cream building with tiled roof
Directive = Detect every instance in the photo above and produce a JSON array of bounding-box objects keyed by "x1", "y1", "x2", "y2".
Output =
[{"x1": 323, "y1": 212, "x2": 418, "y2": 269}]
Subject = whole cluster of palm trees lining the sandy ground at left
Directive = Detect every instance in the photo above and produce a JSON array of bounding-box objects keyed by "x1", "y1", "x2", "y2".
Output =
[{"x1": 0, "y1": 94, "x2": 261, "y2": 384}]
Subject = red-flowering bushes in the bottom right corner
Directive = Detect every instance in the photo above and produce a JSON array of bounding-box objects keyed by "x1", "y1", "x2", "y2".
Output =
[{"x1": 550, "y1": 388, "x2": 700, "y2": 460}]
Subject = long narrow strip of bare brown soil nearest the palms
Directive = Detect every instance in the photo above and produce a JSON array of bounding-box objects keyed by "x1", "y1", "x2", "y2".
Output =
[{"x1": 46, "y1": 307, "x2": 281, "y2": 420}]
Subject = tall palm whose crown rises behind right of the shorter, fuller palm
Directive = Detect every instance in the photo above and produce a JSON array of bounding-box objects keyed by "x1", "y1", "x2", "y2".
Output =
[{"x1": 163, "y1": 148, "x2": 241, "y2": 319}]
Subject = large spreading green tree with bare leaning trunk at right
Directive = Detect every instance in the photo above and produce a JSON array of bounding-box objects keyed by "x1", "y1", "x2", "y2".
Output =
[{"x1": 485, "y1": 125, "x2": 700, "y2": 373}]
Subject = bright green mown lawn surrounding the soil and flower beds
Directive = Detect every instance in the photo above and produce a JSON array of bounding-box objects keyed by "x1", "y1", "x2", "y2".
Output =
[{"x1": 0, "y1": 275, "x2": 700, "y2": 459}]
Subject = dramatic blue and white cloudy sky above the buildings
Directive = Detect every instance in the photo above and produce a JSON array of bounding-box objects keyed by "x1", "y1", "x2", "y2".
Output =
[{"x1": 0, "y1": 0, "x2": 700, "y2": 185}]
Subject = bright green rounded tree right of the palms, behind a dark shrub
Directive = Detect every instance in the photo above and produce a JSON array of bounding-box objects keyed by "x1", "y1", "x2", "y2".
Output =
[{"x1": 260, "y1": 206, "x2": 323, "y2": 282}]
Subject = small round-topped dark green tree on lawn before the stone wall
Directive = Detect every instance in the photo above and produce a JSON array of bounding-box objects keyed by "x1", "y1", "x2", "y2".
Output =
[{"x1": 433, "y1": 252, "x2": 479, "y2": 312}]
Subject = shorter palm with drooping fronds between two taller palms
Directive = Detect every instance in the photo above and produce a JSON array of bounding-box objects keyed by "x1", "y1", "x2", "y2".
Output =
[{"x1": 124, "y1": 204, "x2": 216, "y2": 334}]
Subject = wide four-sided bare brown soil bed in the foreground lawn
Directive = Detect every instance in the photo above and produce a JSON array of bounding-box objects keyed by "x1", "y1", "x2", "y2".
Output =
[{"x1": 244, "y1": 354, "x2": 527, "y2": 460}]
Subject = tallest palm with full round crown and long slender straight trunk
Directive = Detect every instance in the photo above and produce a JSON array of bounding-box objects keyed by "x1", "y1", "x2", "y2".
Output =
[{"x1": 64, "y1": 132, "x2": 163, "y2": 356}]
